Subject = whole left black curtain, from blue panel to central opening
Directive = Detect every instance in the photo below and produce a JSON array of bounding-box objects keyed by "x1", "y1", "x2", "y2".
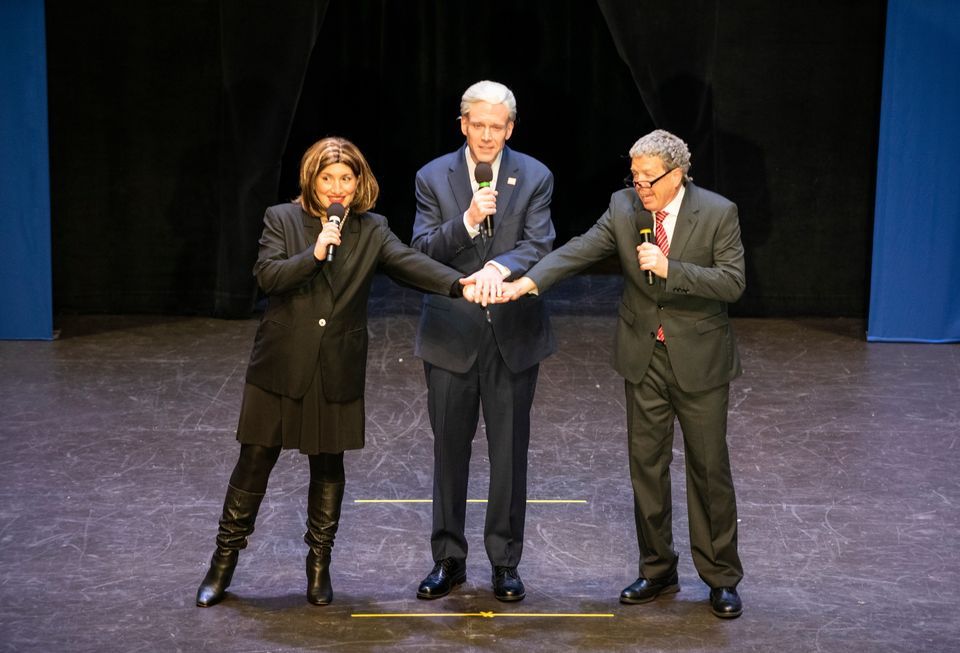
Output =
[{"x1": 47, "y1": 0, "x2": 329, "y2": 317}]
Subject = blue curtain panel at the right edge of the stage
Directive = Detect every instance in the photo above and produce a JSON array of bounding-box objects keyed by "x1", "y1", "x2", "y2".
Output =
[{"x1": 872, "y1": 0, "x2": 960, "y2": 342}]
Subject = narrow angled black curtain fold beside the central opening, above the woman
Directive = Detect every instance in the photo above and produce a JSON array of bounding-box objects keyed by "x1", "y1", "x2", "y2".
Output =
[{"x1": 213, "y1": 0, "x2": 329, "y2": 317}]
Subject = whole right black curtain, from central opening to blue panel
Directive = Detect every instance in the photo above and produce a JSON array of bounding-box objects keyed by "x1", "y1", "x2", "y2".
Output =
[{"x1": 598, "y1": 0, "x2": 886, "y2": 316}]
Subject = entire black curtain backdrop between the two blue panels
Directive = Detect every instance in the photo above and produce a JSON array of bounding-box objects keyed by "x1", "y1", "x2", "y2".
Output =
[{"x1": 47, "y1": 0, "x2": 885, "y2": 316}]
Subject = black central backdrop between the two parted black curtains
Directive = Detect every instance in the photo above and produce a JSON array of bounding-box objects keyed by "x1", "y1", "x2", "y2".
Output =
[{"x1": 280, "y1": 0, "x2": 653, "y2": 258}]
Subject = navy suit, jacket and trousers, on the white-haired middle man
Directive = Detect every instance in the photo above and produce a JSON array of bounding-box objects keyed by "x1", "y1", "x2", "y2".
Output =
[{"x1": 412, "y1": 148, "x2": 556, "y2": 567}]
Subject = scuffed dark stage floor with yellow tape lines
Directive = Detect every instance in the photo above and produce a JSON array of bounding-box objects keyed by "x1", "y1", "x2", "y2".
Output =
[{"x1": 0, "y1": 278, "x2": 960, "y2": 653}]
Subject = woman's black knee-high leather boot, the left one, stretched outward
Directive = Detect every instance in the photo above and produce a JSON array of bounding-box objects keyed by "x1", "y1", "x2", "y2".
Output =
[{"x1": 197, "y1": 484, "x2": 263, "y2": 608}]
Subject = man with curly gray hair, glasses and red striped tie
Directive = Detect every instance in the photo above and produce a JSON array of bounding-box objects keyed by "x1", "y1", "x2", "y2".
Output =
[{"x1": 503, "y1": 129, "x2": 745, "y2": 618}]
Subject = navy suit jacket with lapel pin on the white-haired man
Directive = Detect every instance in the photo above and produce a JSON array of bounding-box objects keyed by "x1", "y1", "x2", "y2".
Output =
[{"x1": 411, "y1": 147, "x2": 556, "y2": 374}]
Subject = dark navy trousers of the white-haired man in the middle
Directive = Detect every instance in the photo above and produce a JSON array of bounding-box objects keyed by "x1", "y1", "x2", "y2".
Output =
[{"x1": 424, "y1": 329, "x2": 539, "y2": 567}]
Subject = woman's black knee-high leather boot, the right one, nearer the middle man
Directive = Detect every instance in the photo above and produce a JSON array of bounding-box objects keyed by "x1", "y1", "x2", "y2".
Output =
[{"x1": 303, "y1": 481, "x2": 344, "y2": 605}]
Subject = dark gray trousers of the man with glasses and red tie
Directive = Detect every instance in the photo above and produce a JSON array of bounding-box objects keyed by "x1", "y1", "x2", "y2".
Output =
[{"x1": 624, "y1": 345, "x2": 743, "y2": 587}]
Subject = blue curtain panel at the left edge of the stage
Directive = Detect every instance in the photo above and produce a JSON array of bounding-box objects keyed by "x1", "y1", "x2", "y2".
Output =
[{"x1": 0, "y1": 0, "x2": 53, "y2": 340}]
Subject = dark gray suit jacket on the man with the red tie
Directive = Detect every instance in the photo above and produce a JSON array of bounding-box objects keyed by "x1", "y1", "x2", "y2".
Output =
[{"x1": 527, "y1": 183, "x2": 745, "y2": 392}]
